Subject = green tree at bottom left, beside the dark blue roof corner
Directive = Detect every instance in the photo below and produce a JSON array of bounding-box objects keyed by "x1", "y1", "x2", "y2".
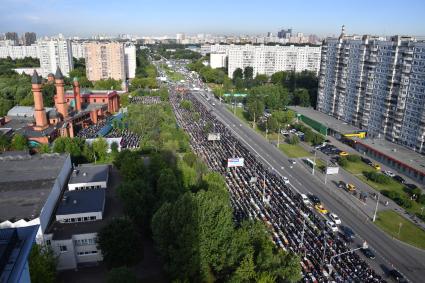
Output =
[{"x1": 28, "y1": 244, "x2": 57, "y2": 283}]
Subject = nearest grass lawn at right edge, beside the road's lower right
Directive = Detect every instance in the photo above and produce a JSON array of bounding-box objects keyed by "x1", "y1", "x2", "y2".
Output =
[{"x1": 375, "y1": 210, "x2": 425, "y2": 249}]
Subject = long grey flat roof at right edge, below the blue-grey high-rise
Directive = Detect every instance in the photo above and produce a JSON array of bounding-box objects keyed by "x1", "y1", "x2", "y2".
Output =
[{"x1": 353, "y1": 138, "x2": 425, "y2": 174}]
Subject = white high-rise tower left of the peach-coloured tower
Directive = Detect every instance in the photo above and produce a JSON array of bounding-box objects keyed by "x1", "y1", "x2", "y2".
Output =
[{"x1": 37, "y1": 39, "x2": 74, "y2": 77}]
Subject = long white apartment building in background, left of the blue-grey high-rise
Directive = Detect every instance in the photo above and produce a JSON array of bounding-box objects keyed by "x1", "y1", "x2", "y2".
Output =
[{"x1": 204, "y1": 44, "x2": 321, "y2": 77}]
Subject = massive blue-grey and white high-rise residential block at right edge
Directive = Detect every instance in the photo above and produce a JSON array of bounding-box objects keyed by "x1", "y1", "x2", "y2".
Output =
[{"x1": 317, "y1": 27, "x2": 425, "y2": 153}]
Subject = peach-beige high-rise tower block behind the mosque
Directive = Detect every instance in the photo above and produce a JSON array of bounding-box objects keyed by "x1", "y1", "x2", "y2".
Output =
[{"x1": 86, "y1": 42, "x2": 126, "y2": 82}]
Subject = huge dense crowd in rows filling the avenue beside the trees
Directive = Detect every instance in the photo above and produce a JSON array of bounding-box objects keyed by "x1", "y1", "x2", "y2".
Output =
[{"x1": 170, "y1": 89, "x2": 385, "y2": 282}]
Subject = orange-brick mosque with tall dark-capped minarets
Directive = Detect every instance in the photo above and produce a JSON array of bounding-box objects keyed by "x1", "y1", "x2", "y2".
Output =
[{"x1": 0, "y1": 67, "x2": 120, "y2": 144}]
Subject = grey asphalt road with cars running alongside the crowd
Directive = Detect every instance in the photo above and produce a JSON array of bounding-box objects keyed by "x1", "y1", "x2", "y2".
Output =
[{"x1": 191, "y1": 90, "x2": 425, "y2": 282}]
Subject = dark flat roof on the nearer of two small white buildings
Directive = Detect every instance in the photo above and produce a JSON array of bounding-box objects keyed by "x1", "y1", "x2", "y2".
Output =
[{"x1": 56, "y1": 189, "x2": 105, "y2": 215}]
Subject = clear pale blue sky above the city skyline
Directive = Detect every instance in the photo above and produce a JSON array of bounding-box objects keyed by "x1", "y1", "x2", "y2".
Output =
[{"x1": 0, "y1": 0, "x2": 425, "y2": 36}]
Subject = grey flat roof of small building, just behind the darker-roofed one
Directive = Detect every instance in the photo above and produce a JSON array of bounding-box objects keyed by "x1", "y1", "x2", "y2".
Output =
[{"x1": 68, "y1": 164, "x2": 109, "y2": 184}]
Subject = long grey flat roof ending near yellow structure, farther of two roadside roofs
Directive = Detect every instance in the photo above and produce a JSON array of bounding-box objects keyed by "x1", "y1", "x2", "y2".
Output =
[{"x1": 288, "y1": 106, "x2": 361, "y2": 134}]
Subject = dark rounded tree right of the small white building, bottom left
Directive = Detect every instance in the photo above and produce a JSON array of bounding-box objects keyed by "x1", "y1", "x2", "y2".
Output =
[{"x1": 98, "y1": 218, "x2": 143, "y2": 267}]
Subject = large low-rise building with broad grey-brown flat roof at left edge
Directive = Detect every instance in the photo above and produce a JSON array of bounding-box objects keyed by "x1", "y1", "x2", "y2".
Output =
[{"x1": 0, "y1": 152, "x2": 71, "y2": 243}]
